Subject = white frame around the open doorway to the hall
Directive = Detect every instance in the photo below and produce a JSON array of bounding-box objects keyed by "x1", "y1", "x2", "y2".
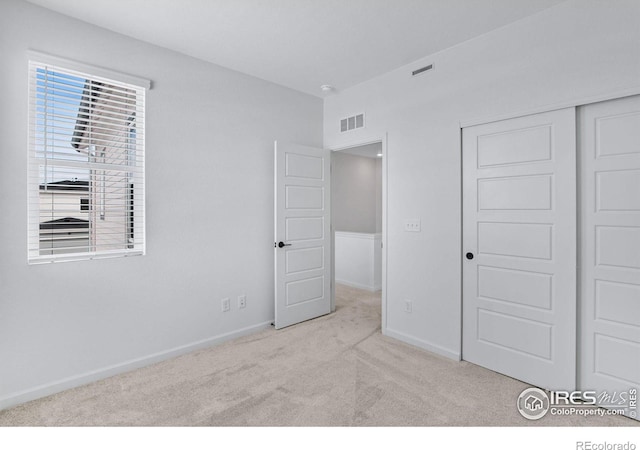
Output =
[{"x1": 325, "y1": 133, "x2": 389, "y2": 334}]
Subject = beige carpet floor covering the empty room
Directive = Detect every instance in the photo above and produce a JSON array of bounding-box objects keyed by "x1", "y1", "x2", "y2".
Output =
[{"x1": 0, "y1": 286, "x2": 640, "y2": 426}]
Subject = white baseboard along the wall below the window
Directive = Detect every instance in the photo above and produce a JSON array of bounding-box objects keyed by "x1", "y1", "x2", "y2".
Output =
[{"x1": 0, "y1": 321, "x2": 272, "y2": 410}]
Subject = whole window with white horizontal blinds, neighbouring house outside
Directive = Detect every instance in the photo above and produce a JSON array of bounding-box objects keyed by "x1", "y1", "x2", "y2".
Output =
[{"x1": 28, "y1": 56, "x2": 145, "y2": 263}]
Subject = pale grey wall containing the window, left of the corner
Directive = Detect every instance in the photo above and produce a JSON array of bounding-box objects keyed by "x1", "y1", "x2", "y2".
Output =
[{"x1": 0, "y1": 0, "x2": 322, "y2": 407}]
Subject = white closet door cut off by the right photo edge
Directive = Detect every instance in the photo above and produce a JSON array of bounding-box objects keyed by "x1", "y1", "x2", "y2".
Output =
[{"x1": 579, "y1": 96, "x2": 640, "y2": 417}]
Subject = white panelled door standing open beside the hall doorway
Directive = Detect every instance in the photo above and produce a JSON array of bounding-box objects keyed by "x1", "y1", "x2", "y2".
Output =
[{"x1": 274, "y1": 142, "x2": 331, "y2": 328}]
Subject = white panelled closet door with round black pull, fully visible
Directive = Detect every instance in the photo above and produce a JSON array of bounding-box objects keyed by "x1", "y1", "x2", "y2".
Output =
[{"x1": 463, "y1": 108, "x2": 576, "y2": 390}]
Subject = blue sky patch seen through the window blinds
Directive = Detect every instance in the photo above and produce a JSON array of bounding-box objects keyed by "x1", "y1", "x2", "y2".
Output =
[{"x1": 35, "y1": 68, "x2": 90, "y2": 184}]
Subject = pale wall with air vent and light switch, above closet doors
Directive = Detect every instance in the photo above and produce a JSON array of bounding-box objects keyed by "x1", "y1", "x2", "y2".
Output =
[{"x1": 324, "y1": 0, "x2": 640, "y2": 358}]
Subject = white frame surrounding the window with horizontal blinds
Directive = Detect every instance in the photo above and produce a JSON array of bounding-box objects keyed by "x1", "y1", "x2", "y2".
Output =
[{"x1": 27, "y1": 51, "x2": 151, "y2": 264}]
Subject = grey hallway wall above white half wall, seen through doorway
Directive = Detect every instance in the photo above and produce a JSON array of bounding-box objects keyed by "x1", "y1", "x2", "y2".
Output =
[{"x1": 331, "y1": 152, "x2": 382, "y2": 233}]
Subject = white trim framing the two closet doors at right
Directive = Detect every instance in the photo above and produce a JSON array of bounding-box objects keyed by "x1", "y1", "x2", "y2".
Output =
[{"x1": 458, "y1": 84, "x2": 640, "y2": 358}]
